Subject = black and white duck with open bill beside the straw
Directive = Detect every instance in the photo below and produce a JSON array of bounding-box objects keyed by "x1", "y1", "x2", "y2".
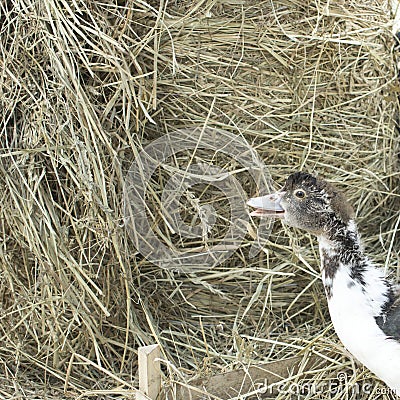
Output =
[{"x1": 247, "y1": 172, "x2": 400, "y2": 396}]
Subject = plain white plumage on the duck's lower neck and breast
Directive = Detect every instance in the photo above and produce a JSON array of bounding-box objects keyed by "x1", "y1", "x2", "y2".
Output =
[{"x1": 328, "y1": 265, "x2": 400, "y2": 394}]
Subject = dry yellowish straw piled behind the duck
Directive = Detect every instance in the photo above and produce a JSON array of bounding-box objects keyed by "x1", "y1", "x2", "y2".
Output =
[{"x1": 0, "y1": 0, "x2": 400, "y2": 399}]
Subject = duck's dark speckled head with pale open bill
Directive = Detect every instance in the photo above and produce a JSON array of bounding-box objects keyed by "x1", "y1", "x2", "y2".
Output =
[{"x1": 247, "y1": 172, "x2": 354, "y2": 236}]
